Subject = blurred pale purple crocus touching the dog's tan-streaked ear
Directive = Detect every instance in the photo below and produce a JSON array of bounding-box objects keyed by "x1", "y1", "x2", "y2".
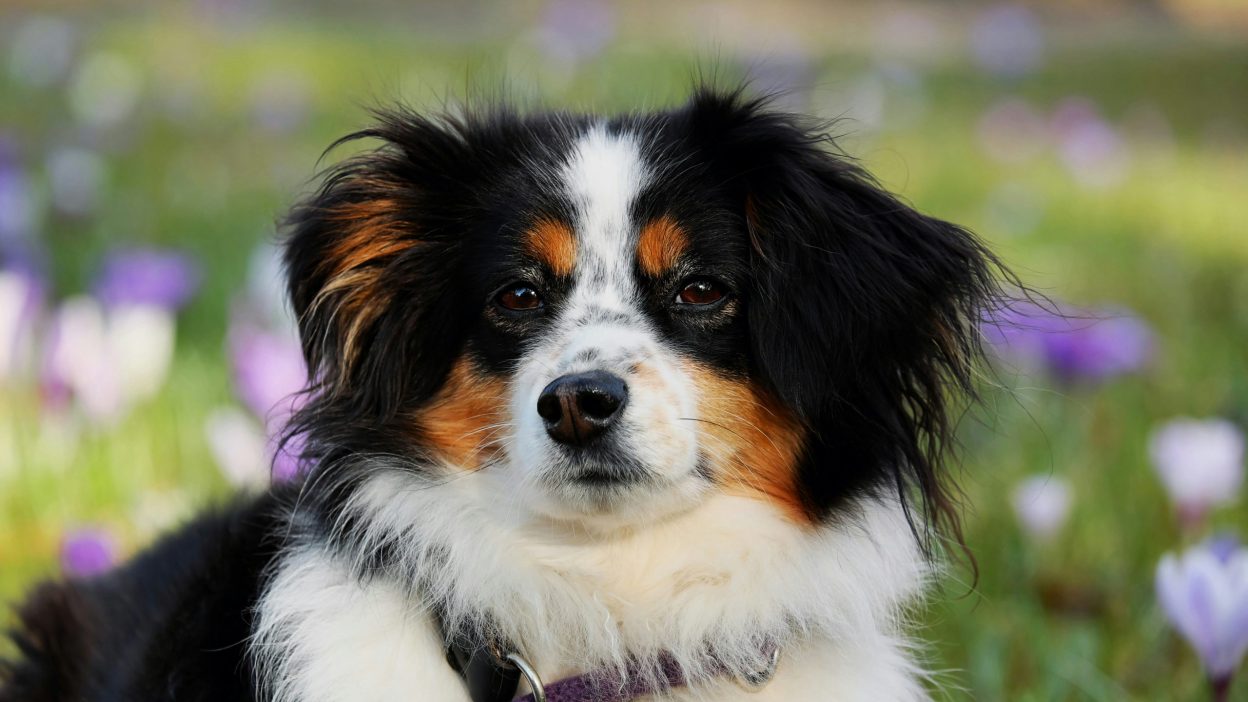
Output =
[{"x1": 230, "y1": 321, "x2": 307, "y2": 427}]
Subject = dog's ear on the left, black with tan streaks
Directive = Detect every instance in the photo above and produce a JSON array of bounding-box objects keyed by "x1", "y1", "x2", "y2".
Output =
[{"x1": 286, "y1": 112, "x2": 472, "y2": 417}]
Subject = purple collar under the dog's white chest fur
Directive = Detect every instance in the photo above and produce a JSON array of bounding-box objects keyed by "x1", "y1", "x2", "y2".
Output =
[{"x1": 507, "y1": 645, "x2": 780, "y2": 702}]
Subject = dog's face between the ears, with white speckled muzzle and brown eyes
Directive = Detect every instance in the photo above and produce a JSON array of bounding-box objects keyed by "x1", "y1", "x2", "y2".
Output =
[{"x1": 499, "y1": 126, "x2": 778, "y2": 521}]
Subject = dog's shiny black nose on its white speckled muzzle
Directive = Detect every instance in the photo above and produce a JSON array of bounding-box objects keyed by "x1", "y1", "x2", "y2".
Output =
[{"x1": 538, "y1": 371, "x2": 628, "y2": 446}]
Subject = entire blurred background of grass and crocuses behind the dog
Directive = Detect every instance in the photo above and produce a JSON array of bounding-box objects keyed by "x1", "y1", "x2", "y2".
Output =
[{"x1": 0, "y1": 0, "x2": 1248, "y2": 700}]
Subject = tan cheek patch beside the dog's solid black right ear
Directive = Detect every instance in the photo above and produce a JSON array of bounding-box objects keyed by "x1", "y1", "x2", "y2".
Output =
[{"x1": 689, "y1": 363, "x2": 811, "y2": 523}]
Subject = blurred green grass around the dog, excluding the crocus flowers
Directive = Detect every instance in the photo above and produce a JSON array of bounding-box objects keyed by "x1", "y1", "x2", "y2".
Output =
[{"x1": 0, "y1": 12, "x2": 1248, "y2": 700}]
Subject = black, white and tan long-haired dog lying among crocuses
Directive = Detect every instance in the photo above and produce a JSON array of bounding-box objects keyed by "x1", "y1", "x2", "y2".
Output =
[{"x1": 0, "y1": 87, "x2": 1005, "y2": 702}]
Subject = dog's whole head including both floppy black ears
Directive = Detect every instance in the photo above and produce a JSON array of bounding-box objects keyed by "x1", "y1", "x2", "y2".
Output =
[{"x1": 287, "y1": 91, "x2": 996, "y2": 542}]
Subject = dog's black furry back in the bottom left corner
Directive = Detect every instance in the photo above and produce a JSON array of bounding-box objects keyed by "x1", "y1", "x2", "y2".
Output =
[{"x1": 0, "y1": 490, "x2": 286, "y2": 702}]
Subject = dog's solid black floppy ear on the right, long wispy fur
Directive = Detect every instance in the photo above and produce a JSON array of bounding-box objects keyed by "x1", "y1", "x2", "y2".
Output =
[{"x1": 688, "y1": 92, "x2": 998, "y2": 547}]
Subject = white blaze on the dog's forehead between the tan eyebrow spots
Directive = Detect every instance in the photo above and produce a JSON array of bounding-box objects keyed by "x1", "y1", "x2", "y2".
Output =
[{"x1": 563, "y1": 125, "x2": 646, "y2": 307}]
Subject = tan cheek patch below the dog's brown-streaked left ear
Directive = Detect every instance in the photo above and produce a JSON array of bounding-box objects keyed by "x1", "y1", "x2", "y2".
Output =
[{"x1": 416, "y1": 358, "x2": 507, "y2": 471}]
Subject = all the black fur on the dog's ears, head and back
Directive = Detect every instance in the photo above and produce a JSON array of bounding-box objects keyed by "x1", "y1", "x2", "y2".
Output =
[{"x1": 0, "y1": 91, "x2": 1003, "y2": 702}]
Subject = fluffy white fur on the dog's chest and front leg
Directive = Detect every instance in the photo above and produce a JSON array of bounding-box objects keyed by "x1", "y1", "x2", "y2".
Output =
[{"x1": 252, "y1": 476, "x2": 925, "y2": 702}]
